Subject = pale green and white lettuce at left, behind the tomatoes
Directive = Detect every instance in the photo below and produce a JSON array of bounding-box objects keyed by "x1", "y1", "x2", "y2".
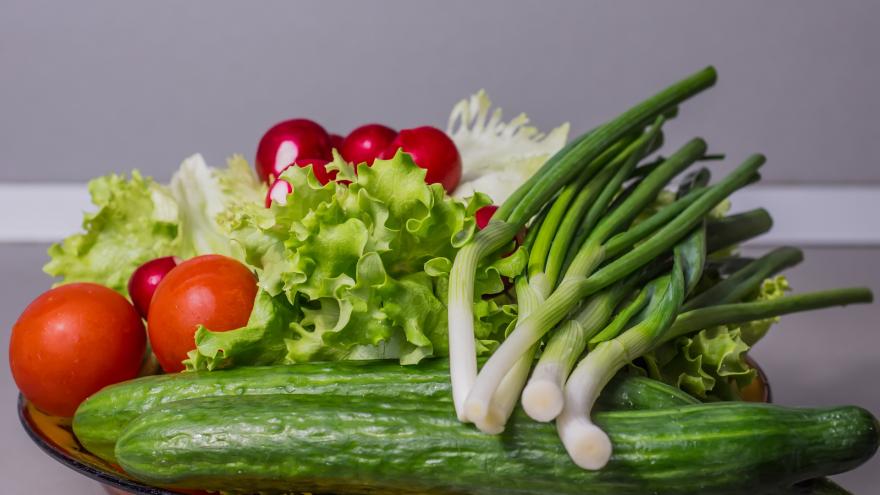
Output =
[{"x1": 43, "y1": 155, "x2": 265, "y2": 294}]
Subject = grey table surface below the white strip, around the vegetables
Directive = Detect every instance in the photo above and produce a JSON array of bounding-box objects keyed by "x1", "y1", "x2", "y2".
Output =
[{"x1": 0, "y1": 244, "x2": 880, "y2": 495}]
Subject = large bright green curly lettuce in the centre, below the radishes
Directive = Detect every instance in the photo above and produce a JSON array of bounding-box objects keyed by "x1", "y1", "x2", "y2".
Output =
[{"x1": 186, "y1": 153, "x2": 525, "y2": 369}]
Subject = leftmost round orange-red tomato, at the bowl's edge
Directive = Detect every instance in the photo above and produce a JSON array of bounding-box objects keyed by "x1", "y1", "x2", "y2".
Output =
[{"x1": 9, "y1": 283, "x2": 146, "y2": 416}]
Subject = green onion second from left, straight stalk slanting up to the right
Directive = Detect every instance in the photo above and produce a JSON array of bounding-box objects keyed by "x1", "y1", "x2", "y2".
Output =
[{"x1": 464, "y1": 154, "x2": 764, "y2": 421}]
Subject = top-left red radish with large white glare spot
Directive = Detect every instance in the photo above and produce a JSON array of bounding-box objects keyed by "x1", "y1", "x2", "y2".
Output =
[{"x1": 256, "y1": 119, "x2": 331, "y2": 183}]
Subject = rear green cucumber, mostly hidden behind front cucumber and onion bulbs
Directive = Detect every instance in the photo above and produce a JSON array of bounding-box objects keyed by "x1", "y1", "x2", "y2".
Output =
[{"x1": 73, "y1": 359, "x2": 696, "y2": 461}]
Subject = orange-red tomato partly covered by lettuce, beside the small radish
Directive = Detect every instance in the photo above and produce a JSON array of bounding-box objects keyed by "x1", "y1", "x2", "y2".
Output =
[{"x1": 147, "y1": 254, "x2": 257, "y2": 373}]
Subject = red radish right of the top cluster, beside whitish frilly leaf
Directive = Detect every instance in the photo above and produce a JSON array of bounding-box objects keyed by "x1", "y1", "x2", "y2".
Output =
[{"x1": 381, "y1": 126, "x2": 461, "y2": 193}]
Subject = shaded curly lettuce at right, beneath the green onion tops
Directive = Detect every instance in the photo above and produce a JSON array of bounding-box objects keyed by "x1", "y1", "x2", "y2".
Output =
[{"x1": 643, "y1": 276, "x2": 789, "y2": 400}]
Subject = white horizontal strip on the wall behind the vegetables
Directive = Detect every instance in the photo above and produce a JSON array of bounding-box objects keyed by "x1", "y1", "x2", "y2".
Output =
[{"x1": 0, "y1": 183, "x2": 880, "y2": 246}]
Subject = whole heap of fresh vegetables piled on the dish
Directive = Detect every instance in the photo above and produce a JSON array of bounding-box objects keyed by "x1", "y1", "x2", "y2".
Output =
[{"x1": 10, "y1": 68, "x2": 880, "y2": 494}]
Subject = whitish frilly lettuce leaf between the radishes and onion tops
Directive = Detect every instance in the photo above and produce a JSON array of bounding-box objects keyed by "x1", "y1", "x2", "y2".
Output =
[{"x1": 446, "y1": 90, "x2": 569, "y2": 204}]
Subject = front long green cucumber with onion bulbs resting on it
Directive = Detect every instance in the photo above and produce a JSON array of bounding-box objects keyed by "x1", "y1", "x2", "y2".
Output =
[{"x1": 116, "y1": 395, "x2": 878, "y2": 495}]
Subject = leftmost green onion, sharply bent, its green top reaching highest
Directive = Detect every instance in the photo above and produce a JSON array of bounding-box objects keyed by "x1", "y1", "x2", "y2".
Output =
[{"x1": 448, "y1": 67, "x2": 717, "y2": 421}]
